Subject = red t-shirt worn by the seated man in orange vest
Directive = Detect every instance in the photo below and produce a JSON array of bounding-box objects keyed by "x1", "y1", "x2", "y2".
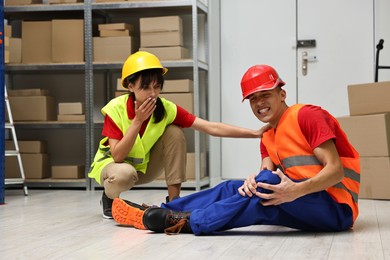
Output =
[{"x1": 260, "y1": 105, "x2": 353, "y2": 158}]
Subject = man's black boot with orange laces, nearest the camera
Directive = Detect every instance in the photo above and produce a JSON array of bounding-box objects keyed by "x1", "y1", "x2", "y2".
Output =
[{"x1": 142, "y1": 208, "x2": 193, "y2": 235}]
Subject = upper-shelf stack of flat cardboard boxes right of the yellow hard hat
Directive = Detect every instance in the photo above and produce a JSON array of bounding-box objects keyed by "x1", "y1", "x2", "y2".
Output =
[{"x1": 140, "y1": 16, "x2": 189, "y2": 60}]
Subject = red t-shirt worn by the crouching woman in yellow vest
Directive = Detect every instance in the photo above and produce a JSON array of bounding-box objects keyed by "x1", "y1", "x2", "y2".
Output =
[{"x1": 102, "y1": 96, "x2": 196, "y2": 140}]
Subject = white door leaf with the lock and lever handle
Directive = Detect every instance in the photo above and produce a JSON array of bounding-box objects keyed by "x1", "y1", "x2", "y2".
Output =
[{"x1": 297, "y1": 0, "x2": 374, "y2": 116}]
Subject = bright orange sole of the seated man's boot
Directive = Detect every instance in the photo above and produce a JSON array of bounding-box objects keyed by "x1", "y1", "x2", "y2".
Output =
[{"x1": 112, "y1": 198, "x2": 146, "y2": 230}]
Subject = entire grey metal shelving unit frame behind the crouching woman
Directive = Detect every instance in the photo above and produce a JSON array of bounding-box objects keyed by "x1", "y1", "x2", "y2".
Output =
[{"x1": 5, "y1": 0, "x2": 209, "y2": 190}]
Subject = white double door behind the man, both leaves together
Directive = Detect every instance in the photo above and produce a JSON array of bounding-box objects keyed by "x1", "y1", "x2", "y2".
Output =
[{"x1": 221, "y1": 0, "x2": 374, "y2": 179}]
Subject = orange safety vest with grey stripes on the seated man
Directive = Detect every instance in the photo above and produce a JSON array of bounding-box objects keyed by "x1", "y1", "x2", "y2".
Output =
[{"x1": 262, "y1": 104, "x2": 360, "y2": 221}]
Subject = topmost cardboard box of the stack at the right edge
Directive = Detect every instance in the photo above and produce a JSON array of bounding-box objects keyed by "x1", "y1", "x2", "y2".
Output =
[{"x1": 348, "y1": 81, "x2": 390, "y2": 116}]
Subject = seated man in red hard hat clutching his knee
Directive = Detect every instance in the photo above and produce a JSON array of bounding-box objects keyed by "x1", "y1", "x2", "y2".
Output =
[{"x1": 113, "y1": 65, "x2": 360, "y2": 235}]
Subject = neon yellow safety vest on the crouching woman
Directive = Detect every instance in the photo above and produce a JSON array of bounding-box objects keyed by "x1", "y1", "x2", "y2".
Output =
[{"x1": 88, "y1": 95, "x2": 177, "y2": 184}]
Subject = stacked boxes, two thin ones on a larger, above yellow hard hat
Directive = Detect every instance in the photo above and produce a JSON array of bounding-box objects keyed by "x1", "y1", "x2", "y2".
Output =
[{"x1": 93, "y1": 23, "x2": 138, "y2": 62}]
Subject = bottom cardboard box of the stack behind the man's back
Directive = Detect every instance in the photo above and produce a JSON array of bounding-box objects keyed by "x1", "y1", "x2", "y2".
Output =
[{"x1": 359, "y1": 157, "x2": 390, "y2": 199}]
